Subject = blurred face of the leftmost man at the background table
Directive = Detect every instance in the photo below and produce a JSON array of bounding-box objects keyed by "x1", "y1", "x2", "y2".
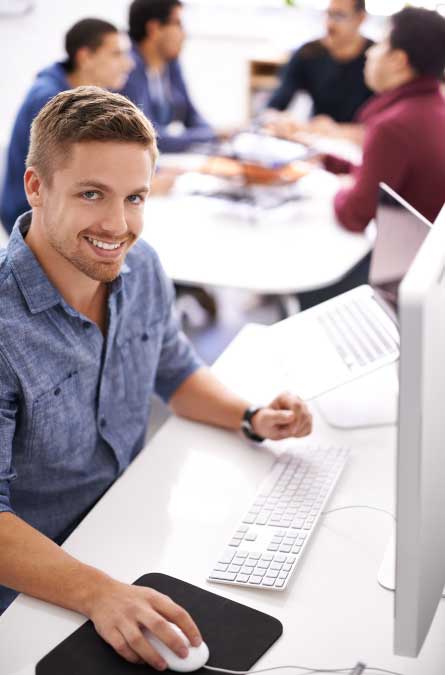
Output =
[{"x1": 82, "y1": 33, "x2": 134, "y2": 89}]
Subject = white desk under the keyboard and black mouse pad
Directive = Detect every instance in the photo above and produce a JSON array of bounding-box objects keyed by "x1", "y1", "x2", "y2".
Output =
[{"x1": 0, "y1": 329, "x2": 445, "y2": 675}]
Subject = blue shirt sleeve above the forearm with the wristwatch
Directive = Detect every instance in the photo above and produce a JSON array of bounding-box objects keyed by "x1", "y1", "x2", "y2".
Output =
[{"x1": 155, "y1": 275, "x2": 203, "y2": 402}]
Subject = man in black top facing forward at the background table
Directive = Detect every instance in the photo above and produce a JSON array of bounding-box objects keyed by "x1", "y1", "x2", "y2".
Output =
[{"x1": 268, "y1": 0, "x2": 372, "y2": 141}]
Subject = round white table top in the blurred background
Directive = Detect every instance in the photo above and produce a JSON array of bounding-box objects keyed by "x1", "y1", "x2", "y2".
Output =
[{"x1": 143, "y1": 168, "x2": 371, "y2": 295}]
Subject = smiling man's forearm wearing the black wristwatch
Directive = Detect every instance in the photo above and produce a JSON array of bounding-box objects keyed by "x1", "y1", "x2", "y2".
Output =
[{"x1": 169, "y1": 368, "x2": 249, "y2": 429}]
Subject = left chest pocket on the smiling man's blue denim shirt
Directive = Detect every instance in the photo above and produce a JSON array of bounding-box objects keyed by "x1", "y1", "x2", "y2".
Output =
[{"x1": 29, "y1": 372, "x2": 85, "y2": 465}]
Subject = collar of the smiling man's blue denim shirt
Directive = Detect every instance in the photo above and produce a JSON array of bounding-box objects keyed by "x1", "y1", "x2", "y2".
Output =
[{"x1": 7, "y1": 211, "x2": 131, "y2": 314}]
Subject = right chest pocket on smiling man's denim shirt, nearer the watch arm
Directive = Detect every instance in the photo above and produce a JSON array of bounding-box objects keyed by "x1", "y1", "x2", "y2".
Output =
[{"x1": 118, "y1": 321, "x2": 163, "y2": 410}]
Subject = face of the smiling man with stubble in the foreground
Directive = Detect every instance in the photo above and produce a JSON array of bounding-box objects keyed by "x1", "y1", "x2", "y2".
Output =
[{"x1": 33, "y1": 142, "x2": 153, "y2": 282}]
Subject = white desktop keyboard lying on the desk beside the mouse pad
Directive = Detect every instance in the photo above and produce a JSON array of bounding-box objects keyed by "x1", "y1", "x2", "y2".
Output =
[{"x1": 208, "y1": 446, "x2": 349, "y2": 591}]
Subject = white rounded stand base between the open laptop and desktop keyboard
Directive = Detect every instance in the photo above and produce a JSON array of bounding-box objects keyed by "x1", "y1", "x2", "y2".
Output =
[{"x1": 316, "y1": 362, "x2": 399, "y2": 429}]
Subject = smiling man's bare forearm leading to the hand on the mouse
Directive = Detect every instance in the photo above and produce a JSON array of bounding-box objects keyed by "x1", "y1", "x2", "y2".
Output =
[{"x1": 0, "y1": 513, "x2": 115, "y2": 616}]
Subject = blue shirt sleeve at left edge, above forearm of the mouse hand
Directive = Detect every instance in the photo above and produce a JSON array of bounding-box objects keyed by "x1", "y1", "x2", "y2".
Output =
[{"x1": 0, "y1": 352, "x2": 18, "y2": 513}]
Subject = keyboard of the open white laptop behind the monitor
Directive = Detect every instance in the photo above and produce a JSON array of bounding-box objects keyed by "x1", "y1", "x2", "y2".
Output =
[{"x1": 317, "y1": 298, "x2": 399, "y2": 370}]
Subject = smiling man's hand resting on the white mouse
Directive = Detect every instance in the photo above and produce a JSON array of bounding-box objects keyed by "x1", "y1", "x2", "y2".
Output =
[{"x1": 88, "y1": 580, "x2": 202, "y2": 670}]
